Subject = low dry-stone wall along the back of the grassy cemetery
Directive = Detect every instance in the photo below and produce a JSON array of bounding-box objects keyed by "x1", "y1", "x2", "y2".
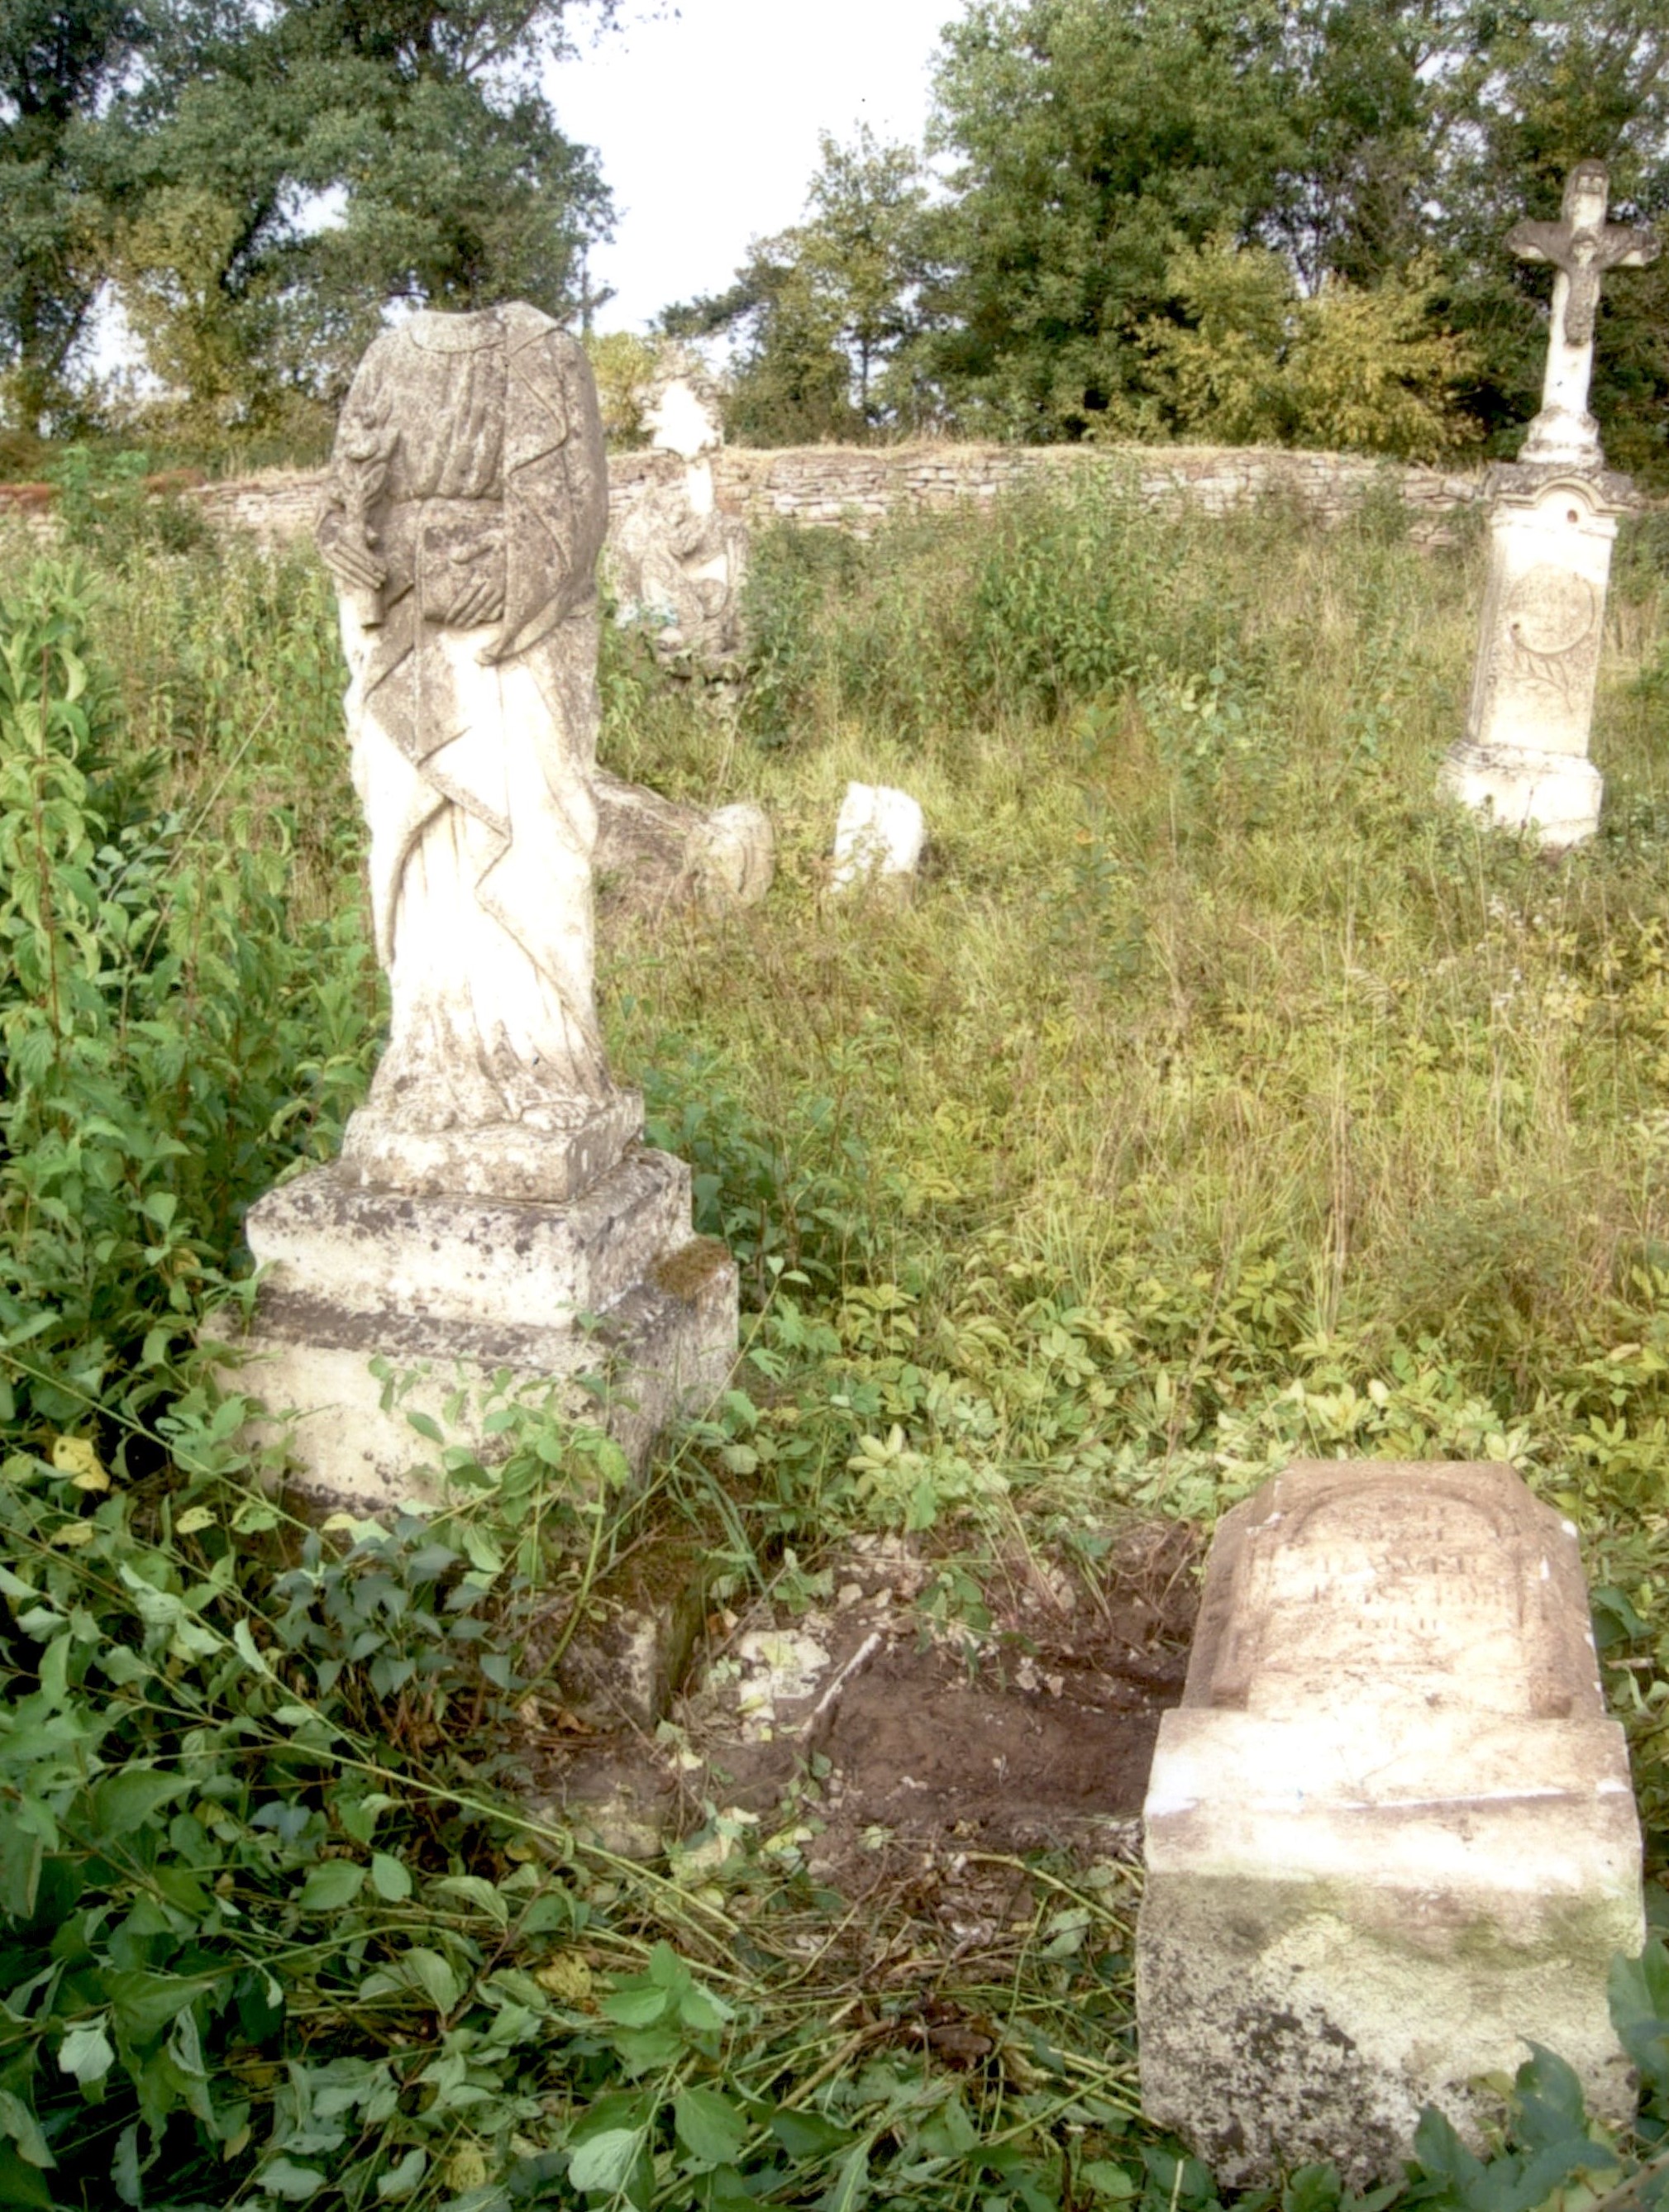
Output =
[{"x1": 199, "y1": 445, "x2": 1483, "y2": 544}]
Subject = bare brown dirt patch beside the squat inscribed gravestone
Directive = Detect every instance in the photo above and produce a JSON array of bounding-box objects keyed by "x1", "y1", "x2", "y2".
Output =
[{"x1": 540, "y1": 1522, "x2": 1198, "y2": 1898}]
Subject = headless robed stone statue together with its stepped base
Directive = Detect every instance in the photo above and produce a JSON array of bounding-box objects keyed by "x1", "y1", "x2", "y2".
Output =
[{"x1": 229, "y1": 305, "x2": 735, "y2": 1511}]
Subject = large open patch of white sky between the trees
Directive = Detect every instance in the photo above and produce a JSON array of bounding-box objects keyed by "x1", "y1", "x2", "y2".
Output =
[{"x1": 551, "y1": 0, "x2": 961, "y2": 330}]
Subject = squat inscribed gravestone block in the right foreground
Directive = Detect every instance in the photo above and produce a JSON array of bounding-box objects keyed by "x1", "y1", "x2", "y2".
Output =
[{"x1": 1137, "y1": 1462, "x2": 1645, "y2": 2186}]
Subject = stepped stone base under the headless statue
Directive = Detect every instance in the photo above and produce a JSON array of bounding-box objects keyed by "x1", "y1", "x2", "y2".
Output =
[{"x1": 235, "y1": 1146, "x2": 737, "y2": 1513}]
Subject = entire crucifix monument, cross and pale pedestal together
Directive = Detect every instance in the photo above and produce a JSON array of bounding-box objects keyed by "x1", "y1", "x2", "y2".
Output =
[{"x1": 1441, "y1": 161, "x2": 1658, "y2": 847}]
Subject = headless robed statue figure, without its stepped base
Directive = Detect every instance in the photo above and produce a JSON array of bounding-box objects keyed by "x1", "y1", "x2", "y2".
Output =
[{"x1": 319, "y1": 307, "x2": 608, "y2": 1135}]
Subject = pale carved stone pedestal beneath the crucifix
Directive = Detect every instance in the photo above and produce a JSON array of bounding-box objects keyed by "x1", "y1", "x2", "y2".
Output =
[{"x1": 1441, "y1": 462, "x2": 1633, "y2": 847}]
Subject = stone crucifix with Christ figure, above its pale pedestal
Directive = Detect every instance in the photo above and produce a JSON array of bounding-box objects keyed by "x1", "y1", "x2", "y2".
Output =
[{"x1": 1508, "y1": 161, "x2": 1658, "y2": 465}]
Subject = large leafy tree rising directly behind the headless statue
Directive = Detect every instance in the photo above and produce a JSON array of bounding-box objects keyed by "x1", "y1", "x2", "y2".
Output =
[{"x1": 0, "y1": 0, "x2": 613, "y2": 431}]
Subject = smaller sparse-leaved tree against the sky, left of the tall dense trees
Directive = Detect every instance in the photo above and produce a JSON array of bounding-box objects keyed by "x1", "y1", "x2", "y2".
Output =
[{"x1": 662, "y1": 124, "x2": 934, "y2": 445}]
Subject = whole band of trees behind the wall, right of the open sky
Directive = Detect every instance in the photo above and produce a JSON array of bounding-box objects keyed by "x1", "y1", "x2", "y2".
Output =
[{"x1": 677, "y1": 0, "x2": 1669, "y2": 469}]
